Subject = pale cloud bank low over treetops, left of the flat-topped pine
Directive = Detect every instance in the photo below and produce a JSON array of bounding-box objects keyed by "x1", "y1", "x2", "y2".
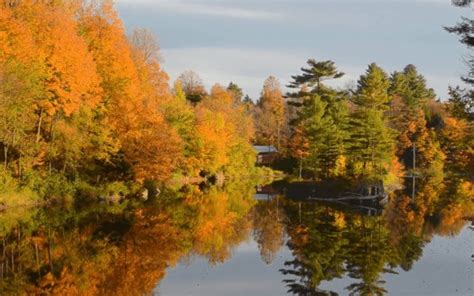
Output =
[{"x1": 163, "y1": 47, "x2": 308, "y2": 99}]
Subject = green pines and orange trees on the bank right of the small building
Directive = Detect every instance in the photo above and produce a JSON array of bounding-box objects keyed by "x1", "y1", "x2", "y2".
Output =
[{"x1": 253, "y1": 59, "x2": 474, "y2": 179}]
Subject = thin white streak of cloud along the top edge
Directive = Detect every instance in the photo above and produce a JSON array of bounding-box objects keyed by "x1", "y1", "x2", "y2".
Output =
[{"x1": 118, "y1": 0, "x2": 284, "y2": 20}]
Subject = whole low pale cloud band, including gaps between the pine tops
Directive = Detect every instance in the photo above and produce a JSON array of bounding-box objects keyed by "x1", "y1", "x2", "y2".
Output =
[{"x1": 163, "y1": 47, "x2": 459, "y2": 99}]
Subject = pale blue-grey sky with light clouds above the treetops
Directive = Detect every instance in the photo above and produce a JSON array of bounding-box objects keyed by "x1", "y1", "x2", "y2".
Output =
[{"x1": 116, "y1": 0, "x2": 473, "y2": 99}]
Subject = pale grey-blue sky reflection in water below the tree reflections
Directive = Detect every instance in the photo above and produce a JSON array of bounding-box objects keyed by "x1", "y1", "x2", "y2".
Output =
[{"x1": 155, "y1": 227, "x2": 474, "y2": 295}]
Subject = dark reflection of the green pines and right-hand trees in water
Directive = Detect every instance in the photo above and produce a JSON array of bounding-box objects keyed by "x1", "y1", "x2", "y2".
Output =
[{"x1": 281, "y1": 175, "x2": 474, "y2": 295}]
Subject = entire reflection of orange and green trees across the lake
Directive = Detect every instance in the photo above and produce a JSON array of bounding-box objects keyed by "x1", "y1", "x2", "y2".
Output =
[{"x1": 0, "y1": 179, "x2": 474, "y2": 295}]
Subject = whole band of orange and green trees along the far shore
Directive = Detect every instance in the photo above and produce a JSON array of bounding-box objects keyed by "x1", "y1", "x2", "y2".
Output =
[{"x1": 0, "y1": 1, "x2": 474, "y2": 207}]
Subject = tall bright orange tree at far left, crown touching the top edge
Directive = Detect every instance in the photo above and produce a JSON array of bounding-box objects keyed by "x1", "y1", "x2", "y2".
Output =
[{"x1": 1, "y1": 1, "x2": 112, "y2": 178}]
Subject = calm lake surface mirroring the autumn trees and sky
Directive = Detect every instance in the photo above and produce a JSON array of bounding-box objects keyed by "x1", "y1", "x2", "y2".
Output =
[{"x1": 0, "y1": 180, "x2": 474, "y2": 296}]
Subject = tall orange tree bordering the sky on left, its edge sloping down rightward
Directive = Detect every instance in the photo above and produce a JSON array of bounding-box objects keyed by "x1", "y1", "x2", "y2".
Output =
[{"x1": 80, "y1": 2, "x2": 181, "y2": 181}]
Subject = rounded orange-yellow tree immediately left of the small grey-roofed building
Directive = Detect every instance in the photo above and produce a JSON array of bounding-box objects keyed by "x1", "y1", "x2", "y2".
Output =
[{"x1": 190, "y1": 84, "x2": 255, "y2": 178}]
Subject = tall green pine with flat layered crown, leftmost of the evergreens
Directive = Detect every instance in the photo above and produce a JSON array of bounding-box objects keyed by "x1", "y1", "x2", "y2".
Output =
[{"x1": 287, "y1": 59, "x2": 349, "y2": 177}]
